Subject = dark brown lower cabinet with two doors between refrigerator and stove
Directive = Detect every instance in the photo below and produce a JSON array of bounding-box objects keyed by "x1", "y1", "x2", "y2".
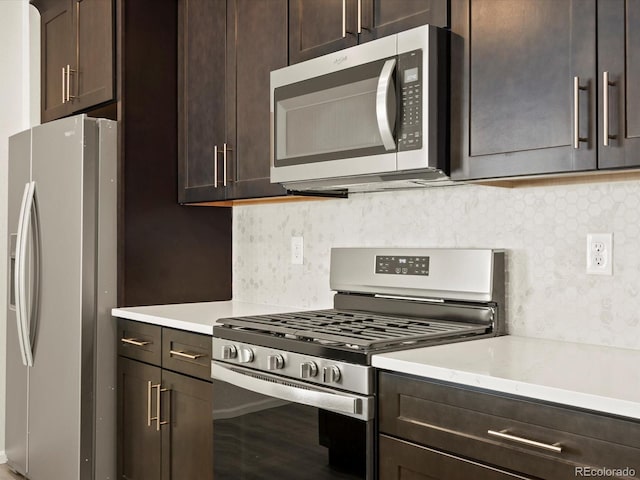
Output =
[{"x1": 118, "y1": 319, "x2": 213, "y2": 480}]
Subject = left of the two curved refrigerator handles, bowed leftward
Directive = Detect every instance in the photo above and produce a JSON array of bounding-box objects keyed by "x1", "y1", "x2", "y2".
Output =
[{"x1": 16, "y1": 182, "x2": 36, "y2": 367}]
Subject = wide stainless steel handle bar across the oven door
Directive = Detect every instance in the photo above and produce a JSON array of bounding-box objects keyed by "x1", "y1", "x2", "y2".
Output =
[{"x1": 211, "y1": 361, "x2": 373, "y2": 420}]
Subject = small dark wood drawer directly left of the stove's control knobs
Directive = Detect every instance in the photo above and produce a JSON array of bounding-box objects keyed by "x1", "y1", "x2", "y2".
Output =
[{"x1": 162, "y1": 328, "x2": 211, "y2": 381}]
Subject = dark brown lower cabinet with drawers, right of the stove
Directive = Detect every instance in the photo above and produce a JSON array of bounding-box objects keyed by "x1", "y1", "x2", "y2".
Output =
[{"x1": 378, "y1": 372, "x2": 640, "y2": 480}]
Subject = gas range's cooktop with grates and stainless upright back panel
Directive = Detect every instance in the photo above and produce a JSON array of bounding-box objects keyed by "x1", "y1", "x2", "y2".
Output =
[{"x1": 214, "y1": 248, "x2": 504, "y2": 378}]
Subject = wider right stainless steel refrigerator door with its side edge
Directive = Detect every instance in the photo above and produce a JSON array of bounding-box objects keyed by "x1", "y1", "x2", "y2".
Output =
[{"x1": 29, "y1": 115, "x2": 97, "y2": 480}]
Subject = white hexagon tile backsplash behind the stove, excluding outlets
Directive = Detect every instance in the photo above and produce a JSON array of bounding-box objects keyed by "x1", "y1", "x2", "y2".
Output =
[{"x1": 233, "y1": 182, "x2": 640, "y2": 349}]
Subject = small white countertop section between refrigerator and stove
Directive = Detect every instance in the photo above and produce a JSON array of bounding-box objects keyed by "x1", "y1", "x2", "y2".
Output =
[{"x1": 111, "y1": 300, "x2": 300, "y2": 335}]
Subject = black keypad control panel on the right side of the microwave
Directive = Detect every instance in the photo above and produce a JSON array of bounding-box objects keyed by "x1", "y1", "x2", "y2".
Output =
[{"x1": 398, "y1": 50, "x2": 423, "y2": 151}]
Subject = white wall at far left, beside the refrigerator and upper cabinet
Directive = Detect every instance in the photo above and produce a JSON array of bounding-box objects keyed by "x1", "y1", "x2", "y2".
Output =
[{"x1": 0, "y1": 0, "x2": 40, "y2": 461}]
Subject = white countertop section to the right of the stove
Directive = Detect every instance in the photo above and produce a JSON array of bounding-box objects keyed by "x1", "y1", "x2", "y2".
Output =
[{"x1": 373, "y1": 335, "x2": 640, "y2": 419}]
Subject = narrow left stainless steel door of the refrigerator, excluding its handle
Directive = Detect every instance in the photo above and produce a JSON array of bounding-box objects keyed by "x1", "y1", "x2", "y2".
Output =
[{"x1": 5, "y1": 130, "x2": 31, "y2": 475}]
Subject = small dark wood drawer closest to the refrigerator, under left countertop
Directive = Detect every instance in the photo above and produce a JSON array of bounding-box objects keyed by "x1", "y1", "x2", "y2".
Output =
[{"x1": 118, "y1": 318, "x2": 162, "y2": 365}]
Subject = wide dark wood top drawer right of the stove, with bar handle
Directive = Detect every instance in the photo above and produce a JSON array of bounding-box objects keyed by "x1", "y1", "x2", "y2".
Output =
[{"x1": 380, "y1": 373, "x2": 640, "y2": 479}]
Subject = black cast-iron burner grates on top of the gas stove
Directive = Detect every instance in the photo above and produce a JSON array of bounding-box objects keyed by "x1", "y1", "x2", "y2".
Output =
[{"x1": 221, "y1": 310, "x2": 487, "y2": 349}]
